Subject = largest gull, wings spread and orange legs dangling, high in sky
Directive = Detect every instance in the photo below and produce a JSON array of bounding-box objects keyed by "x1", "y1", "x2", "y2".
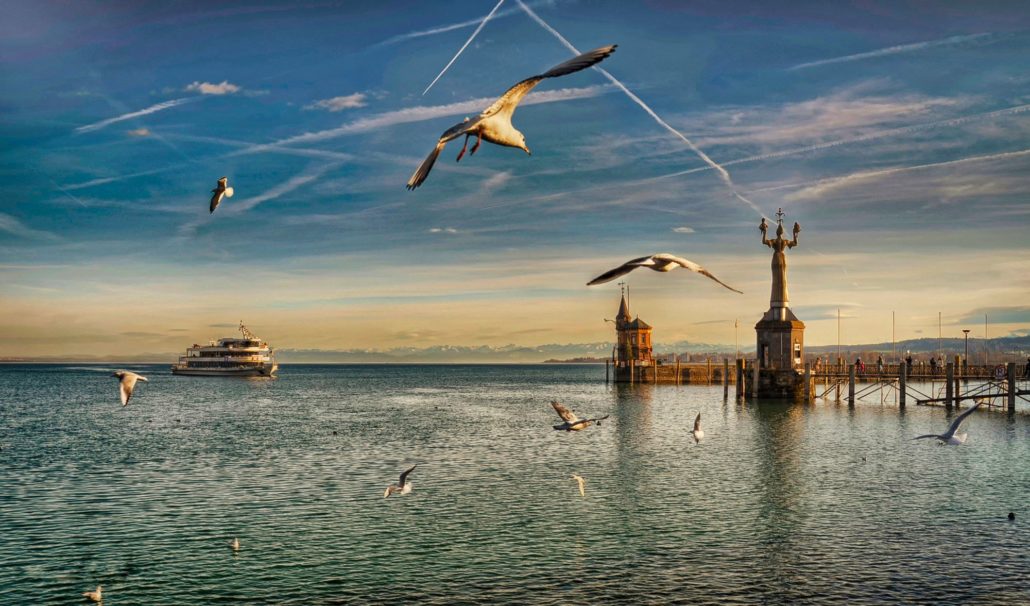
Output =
[{"x1": 407, "y1": 44, "x2": 616, "y2": 190}]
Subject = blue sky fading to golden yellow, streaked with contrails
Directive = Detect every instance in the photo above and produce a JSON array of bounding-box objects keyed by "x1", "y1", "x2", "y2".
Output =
[{"x1": 0, "y1": 0, "x2": 1030, "y2": 359}]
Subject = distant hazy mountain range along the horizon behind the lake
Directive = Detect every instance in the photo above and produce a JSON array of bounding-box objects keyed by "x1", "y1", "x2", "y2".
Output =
[{"x1": 0, "y1": 336, "x2": 1030, "y2": 364}]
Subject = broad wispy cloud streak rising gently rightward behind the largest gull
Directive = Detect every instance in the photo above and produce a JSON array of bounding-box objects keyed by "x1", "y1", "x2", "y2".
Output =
[{"x1": 236, "y1": 86, "x2": 610, "y2": 154}]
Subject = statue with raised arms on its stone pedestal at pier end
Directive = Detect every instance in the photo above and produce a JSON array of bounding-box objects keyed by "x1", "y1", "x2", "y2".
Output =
[{"x1": 755, "y1": 208, "x2": 804, "y2": 398}]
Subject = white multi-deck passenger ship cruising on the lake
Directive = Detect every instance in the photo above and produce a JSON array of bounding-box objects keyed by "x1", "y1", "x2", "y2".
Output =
[{"x1": 172, "y1": 322, "x2": 279, "y2": 377}]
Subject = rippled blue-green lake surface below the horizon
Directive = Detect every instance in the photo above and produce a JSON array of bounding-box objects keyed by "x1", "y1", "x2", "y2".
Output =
[{"x1": 0, "y1": 365, "x2": 1030, "y2": 606}]
